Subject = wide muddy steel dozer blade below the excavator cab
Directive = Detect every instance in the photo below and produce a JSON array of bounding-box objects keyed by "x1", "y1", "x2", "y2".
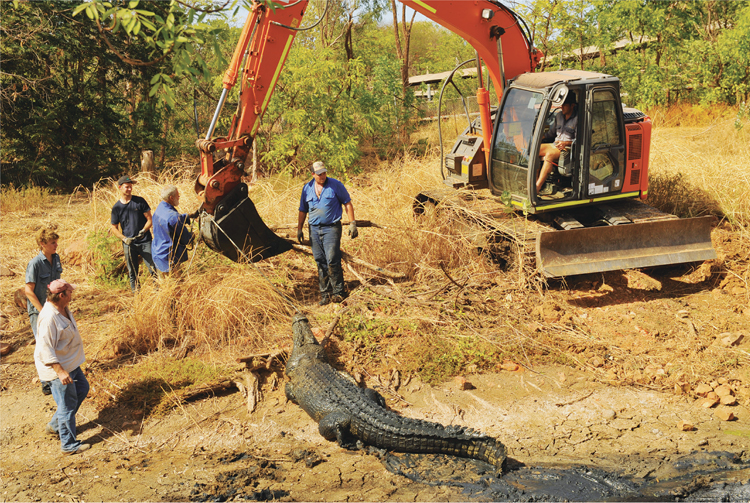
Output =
[{"x1": 536, "y1": 216, "x2": 716, "y2": 278}]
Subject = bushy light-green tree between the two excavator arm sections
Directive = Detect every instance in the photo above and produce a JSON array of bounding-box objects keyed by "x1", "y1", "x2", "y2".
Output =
[{"x1": 260, "y1": 39, "x2": 414, "y2": 177}]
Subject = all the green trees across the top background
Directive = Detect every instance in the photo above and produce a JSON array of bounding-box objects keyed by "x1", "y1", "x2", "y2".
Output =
[{"x1": 0, "y1": 0, "x2": 750, "y2": 189}]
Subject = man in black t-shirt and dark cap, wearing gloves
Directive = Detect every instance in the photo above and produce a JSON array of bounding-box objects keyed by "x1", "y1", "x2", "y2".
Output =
[{"x1": 110, "y1": 175, "x2": 156, "y2": 291}]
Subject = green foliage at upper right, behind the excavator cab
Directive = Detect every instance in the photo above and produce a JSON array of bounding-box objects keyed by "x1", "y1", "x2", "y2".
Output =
[{"x1": 519, "y1": 0, "x2": 750, "y2": 107}]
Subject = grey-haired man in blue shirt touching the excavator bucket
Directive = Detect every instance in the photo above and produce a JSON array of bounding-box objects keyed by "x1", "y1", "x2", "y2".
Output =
[{"x1": 154, "y1": 185, "x2": 198, "y2": 273}]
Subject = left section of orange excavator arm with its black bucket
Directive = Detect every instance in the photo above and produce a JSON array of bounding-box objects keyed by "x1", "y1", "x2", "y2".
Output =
[{"x1": 195, "y1": 0, "x2": 308, "y2": 262}]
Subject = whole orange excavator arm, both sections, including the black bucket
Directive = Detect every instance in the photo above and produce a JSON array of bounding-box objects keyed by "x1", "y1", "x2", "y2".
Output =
[{"x1": 195, "y1": 0, "x2": 541, "y2": 261}]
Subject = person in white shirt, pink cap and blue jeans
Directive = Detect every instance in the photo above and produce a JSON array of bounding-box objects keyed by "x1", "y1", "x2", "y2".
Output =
[{"x1": 34, "y1": 279, "x2": 91, "y2": 454}]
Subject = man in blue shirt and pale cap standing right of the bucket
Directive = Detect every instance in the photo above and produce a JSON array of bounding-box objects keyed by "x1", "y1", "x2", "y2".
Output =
[{"x1": 297, "y1": 161, "x2": 359, "y2": 306}]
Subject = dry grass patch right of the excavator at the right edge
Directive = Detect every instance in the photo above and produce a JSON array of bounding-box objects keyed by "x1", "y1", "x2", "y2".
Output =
[{"x1": 649, "y1": 119, "x2": 750, "y2": 227}]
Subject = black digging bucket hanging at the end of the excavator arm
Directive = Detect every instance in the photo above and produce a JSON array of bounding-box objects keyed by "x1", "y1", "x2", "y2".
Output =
[{"x1": 201, "y1": 183, "x2": 292, "y2": 262}]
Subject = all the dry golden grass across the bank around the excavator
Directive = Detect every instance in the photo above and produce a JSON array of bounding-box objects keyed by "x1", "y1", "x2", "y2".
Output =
[{"x1": 2, "y1": 116, "x2": 750, "y2": 404}]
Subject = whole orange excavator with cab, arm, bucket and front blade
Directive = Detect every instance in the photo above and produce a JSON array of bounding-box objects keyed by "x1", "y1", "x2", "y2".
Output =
[{"x1": 195, "y1": 0, "x2": 716, "y2": 277}]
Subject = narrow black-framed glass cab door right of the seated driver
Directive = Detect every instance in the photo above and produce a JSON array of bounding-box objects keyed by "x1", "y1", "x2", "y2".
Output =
[{"x1": 581, "y1": 85, "x2": 625, "y2": 199}]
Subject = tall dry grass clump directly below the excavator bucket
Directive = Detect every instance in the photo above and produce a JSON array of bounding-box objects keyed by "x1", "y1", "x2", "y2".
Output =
[{"x1": 114, "y1": 264, "x2": 294, "y2": 354}]
